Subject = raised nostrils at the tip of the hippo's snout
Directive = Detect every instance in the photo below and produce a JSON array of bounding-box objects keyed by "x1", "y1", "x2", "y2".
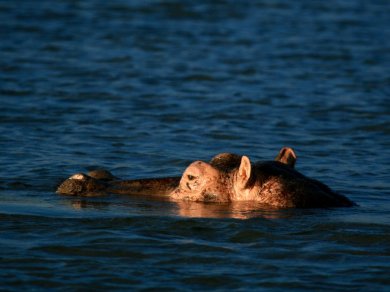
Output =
[{"x1": 57, "y1": 173, "x2": 106, "y2": 195}]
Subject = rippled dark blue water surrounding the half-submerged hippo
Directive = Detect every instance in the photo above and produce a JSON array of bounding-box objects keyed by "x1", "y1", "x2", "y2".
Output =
[{"x1": 0, "y1": 0, "x2": 390, "y2": 291}]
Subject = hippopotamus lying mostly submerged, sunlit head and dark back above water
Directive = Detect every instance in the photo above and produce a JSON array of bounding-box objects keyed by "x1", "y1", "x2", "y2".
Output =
[{"x1": 57, "y1": 147, "x2": 355, "y2": 208}]
